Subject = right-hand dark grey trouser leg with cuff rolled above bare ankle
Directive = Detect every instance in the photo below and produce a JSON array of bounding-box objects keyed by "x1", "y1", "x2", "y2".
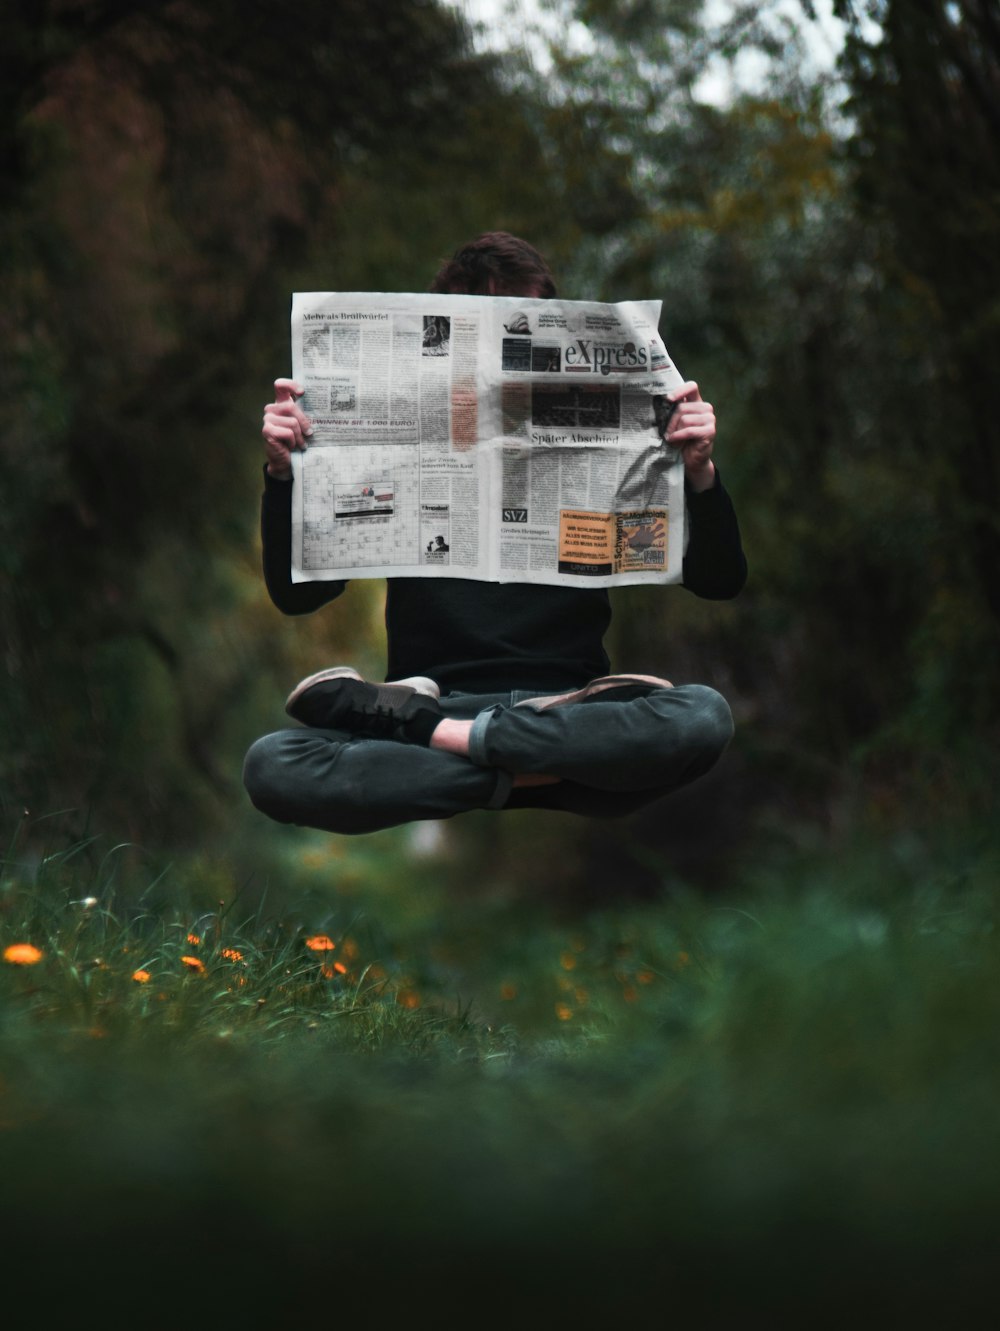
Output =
[{"x1": 470, "y1": 684, "x2": 732, "y2": 816}]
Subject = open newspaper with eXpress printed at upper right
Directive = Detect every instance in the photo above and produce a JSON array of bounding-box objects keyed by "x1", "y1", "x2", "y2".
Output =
[{"x1": 292, "y1": 291, "x2": 686, "y2": 587}]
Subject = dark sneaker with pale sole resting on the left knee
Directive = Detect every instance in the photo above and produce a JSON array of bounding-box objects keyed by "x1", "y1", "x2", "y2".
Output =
[{"x1": 285, "y1": 666, "x2": 443, "y2": 744}]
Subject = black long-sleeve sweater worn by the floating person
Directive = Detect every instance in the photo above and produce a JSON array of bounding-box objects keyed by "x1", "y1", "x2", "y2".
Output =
[{"x1": 261, "y1": 469, "x2": 747, "y2": 693}]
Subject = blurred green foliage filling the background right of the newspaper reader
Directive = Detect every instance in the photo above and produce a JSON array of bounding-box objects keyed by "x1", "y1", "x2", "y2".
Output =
[{"x1": 503, "y1": 4, "x2": 1000, "y2": 847}]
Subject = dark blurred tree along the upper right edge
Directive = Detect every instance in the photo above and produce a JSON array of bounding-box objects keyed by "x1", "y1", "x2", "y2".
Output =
[{"x1": 836, "y1": 0, "x2": 1000, "y2": 729}]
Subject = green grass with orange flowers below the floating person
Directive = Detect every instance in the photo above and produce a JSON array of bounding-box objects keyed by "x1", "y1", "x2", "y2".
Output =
[{"x1": 0, "y1": 809, "x2": 1000, "y2": 1327}]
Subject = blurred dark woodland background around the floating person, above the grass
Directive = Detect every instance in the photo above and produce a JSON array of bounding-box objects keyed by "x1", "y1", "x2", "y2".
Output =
[{"x1": 0, "y1": 0, "x2": 1000, "y2": 901}]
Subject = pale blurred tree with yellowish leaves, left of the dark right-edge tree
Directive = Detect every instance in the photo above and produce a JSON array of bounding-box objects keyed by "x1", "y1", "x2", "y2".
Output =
[{"x1": 490, "y1": 0, "x2": 884, "y2": 851}]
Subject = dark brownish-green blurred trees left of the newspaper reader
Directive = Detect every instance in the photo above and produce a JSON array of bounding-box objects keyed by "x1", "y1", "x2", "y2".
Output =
[{"x1": 0, "y1": 0, "x2": 577, "y2": 843}]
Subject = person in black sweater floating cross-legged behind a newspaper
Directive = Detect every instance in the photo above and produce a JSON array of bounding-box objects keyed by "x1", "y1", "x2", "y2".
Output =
[{"x1": 244, "y1": 232, "x2": 747, "y2": 835}]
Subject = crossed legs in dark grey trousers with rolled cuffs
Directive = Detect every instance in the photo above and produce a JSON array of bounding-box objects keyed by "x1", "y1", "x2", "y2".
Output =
[{"x1": 244, "y1": 684, "x2": 732, "y2": 835}]
